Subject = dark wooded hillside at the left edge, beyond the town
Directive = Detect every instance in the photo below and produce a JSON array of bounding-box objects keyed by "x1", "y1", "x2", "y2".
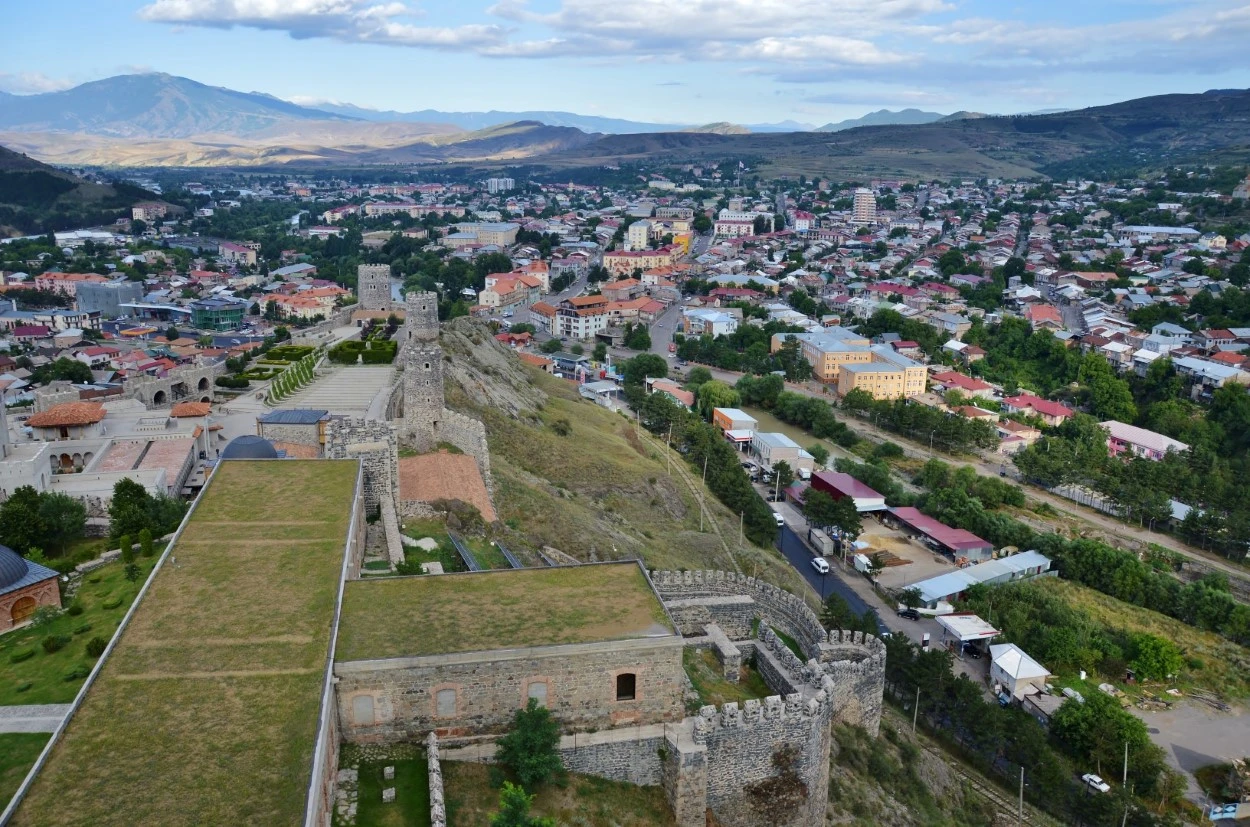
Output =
[{"x1": 0, "y1": 146, "x2": 156, "y2": 237}]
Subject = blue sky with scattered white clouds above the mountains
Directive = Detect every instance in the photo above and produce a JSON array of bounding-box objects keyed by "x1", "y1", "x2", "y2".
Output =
[{"x1": 0, "y1": 0, "x2": 1250, "y2": 125}]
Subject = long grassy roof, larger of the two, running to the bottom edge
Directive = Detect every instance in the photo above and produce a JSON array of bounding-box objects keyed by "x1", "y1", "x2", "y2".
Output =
[{"x1": 11, "y1": 460, "x2": 356, "y2": 826}]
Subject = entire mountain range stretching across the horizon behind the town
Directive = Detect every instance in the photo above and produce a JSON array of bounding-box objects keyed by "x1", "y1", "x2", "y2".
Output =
[{"x1": 0, "y1": 74, "x2": 1250, "y2": 180}]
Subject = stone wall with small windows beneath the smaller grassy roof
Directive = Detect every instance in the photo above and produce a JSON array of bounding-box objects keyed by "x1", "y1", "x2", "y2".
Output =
[{"x1": 335, "y1": 637, "x2": 686, "y2": 743}]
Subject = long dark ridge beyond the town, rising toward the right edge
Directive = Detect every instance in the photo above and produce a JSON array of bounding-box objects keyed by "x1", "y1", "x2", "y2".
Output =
[{"x1": 534, "y1": 90, "x2": 1250, "y2": 180}]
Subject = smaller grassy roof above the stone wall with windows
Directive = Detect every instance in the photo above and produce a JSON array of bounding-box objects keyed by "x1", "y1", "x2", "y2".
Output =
[{"x1": 335, "y1": 562, "x2": 676, "y2": 661}]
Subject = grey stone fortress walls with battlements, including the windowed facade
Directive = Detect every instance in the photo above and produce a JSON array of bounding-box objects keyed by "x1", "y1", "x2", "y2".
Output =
[{"x1": 335, "y1": 571, "x2": 885, "y2": 827}]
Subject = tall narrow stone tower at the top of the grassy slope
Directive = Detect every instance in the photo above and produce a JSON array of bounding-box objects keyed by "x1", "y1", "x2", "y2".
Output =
[{"x1": 400, "y1": 292, "x2": 444, "y2": 452}]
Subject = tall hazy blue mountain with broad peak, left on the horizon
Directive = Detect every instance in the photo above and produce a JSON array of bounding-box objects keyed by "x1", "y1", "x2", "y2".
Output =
[{"x1": 0, "y1": 74, "x2": 358, "y2": 137}]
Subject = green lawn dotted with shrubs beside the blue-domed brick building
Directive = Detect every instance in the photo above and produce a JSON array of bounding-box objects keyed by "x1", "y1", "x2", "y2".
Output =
[{"x1": 0, "y1": 557, "x2": 148, "y2": 706}]
